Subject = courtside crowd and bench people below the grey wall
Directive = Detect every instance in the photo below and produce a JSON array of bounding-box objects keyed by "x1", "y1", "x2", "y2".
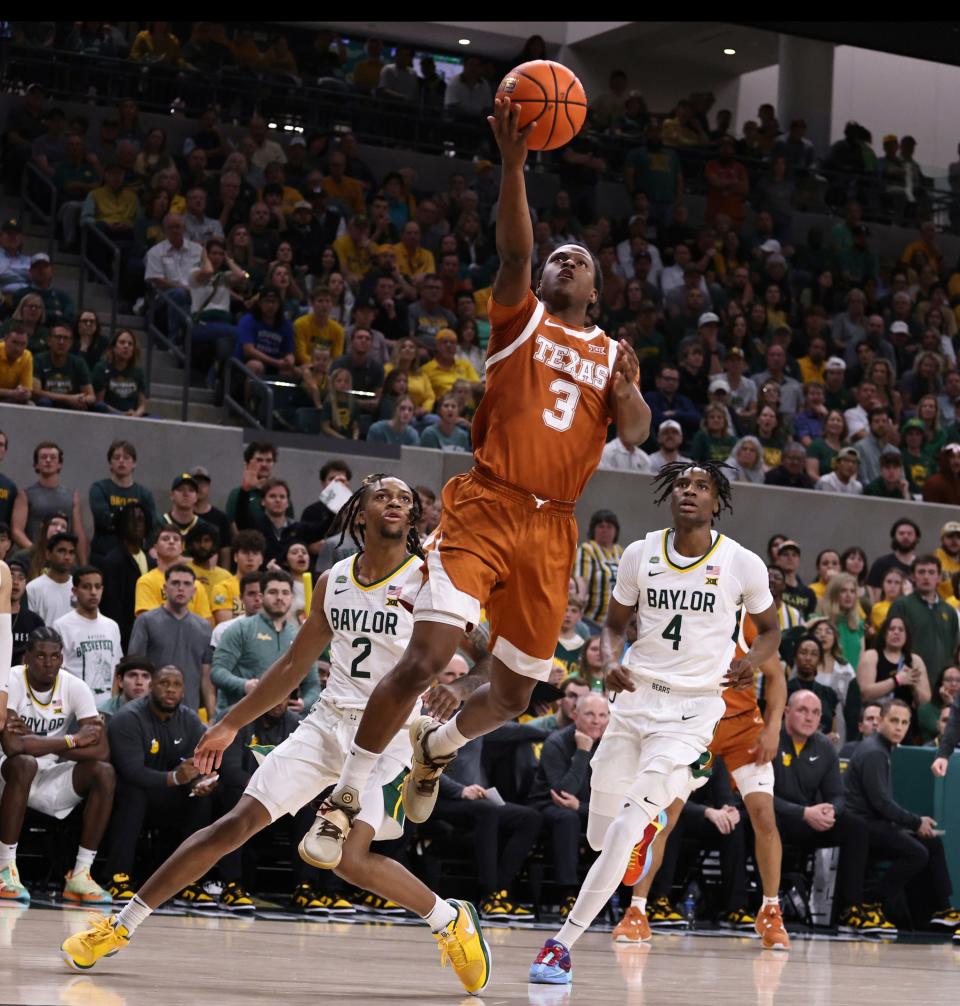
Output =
[{"x1": 0, "y1": 434, "x2": 960, "y2": 929}]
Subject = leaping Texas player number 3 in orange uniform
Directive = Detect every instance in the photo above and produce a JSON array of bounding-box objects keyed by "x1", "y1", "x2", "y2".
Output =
[{"x1": 301, "y1": 99, "x2": 650, "y2": 868}]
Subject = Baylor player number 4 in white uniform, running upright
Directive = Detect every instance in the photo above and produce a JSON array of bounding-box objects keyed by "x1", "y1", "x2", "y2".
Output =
[{"x1": 529, "y1": 462, "x2": 780, "y2": 985}]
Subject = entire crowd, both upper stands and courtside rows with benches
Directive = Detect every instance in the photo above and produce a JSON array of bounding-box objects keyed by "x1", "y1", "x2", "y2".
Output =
[{"x1": 0, "y1": 22, "x2": 960, "y2": 929}]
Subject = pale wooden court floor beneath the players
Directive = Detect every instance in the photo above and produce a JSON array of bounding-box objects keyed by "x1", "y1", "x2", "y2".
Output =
[{"x1": 0, "y1": 905, "x2": 960, "y2": 1006}]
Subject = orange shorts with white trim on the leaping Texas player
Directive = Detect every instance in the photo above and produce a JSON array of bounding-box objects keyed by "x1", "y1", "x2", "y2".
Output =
[{"x1": 414, "y1": 468, "x2": 577, "y2": 681}]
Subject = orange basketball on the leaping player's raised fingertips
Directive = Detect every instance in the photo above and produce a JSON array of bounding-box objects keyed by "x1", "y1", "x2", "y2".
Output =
[{"x1": 497, "y1": 59, "x2": 587, "y2": 150}]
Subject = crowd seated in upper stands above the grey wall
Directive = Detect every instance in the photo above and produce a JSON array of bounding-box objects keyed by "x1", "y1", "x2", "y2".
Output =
[{"x1": 0, "y1": 22, "x2": 960, "y2": 474}]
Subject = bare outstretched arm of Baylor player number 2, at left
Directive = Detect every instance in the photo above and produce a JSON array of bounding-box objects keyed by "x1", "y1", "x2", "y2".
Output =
[{"x1": 193, "y1": 573, "x2": 333, "y2": 775}]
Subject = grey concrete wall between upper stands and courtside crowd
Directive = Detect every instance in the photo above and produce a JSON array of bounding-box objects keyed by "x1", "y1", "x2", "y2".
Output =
[{"x1": 0, "y1": 405, "x2": 958, "y2": 574}]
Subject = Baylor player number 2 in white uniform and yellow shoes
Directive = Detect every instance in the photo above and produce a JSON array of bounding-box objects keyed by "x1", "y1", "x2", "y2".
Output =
[{"x1": 61, "y1": 475, "x2": 490, "y2": 993}]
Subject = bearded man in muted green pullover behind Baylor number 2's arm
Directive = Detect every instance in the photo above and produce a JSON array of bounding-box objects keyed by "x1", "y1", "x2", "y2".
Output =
[{"x1": 211, "y1": 570, "x2": 320, "y2": 718}]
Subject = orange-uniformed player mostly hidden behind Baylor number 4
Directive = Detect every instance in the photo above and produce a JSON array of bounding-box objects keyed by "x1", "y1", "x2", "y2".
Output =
[{"x1": 613, "y1": 612, "x2": 790, "y2": 950}]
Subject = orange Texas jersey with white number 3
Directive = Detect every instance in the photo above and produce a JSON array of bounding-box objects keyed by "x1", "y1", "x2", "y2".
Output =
[{"x1": 471, "y1": 292, "x2": 617, "y2": 501}]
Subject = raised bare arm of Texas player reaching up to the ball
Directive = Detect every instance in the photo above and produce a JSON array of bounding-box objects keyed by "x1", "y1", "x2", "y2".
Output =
[{"x1": 487, "y1": 98, "x2": 536, "y2": 307}]
